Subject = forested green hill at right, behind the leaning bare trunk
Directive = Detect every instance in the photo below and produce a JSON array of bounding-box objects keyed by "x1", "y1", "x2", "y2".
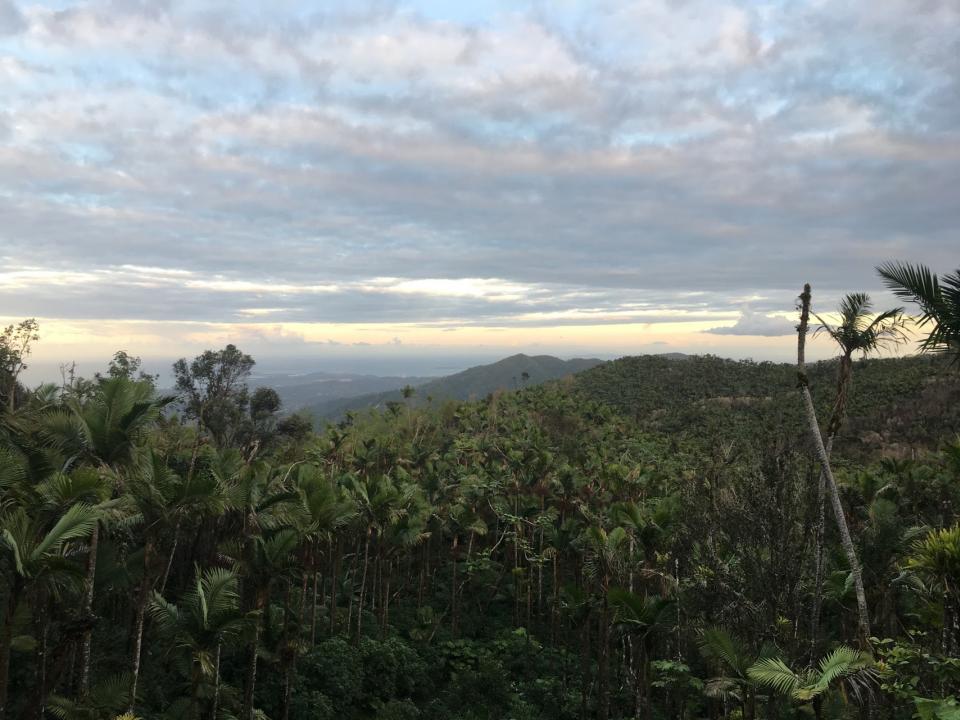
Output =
[{"x1": 572, "y1": 355, "x2": 960, "y2": 456}]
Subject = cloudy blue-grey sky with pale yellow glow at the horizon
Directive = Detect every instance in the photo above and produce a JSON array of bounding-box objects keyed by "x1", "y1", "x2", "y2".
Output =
[{"x1": 0, "y1": 0, "x2": 960, "y2": 380}]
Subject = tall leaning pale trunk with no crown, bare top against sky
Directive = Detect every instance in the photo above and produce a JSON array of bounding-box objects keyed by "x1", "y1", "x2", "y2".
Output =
[{"x1": 797, "y1": 285, "x2": 870, "y2": 650}]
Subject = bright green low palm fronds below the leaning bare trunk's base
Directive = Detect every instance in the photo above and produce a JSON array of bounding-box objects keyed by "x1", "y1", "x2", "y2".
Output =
[{"x1": 747, "y1": 645, "x2": 879, "y2": 720}]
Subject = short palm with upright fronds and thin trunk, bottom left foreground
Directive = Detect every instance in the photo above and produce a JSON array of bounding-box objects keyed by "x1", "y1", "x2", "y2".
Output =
[{"x1": 150, "y1": 568, "x2": 249, "y2": 720}]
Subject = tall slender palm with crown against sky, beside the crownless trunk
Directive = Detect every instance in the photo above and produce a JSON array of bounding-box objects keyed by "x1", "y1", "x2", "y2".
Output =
[{"x1": 810, "y1": 293, "x2": 906, "y2": 645}]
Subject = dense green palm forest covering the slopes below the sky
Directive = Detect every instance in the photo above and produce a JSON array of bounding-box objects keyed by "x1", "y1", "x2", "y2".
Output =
[{"x1": 0, "y1": 268, "x2": 960, "y2": 720}]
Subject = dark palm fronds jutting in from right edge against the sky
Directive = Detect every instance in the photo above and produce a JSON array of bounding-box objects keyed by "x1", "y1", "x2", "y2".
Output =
[{"x1": 877, "y1": 262, "x2": 960, "y2": 364}]
